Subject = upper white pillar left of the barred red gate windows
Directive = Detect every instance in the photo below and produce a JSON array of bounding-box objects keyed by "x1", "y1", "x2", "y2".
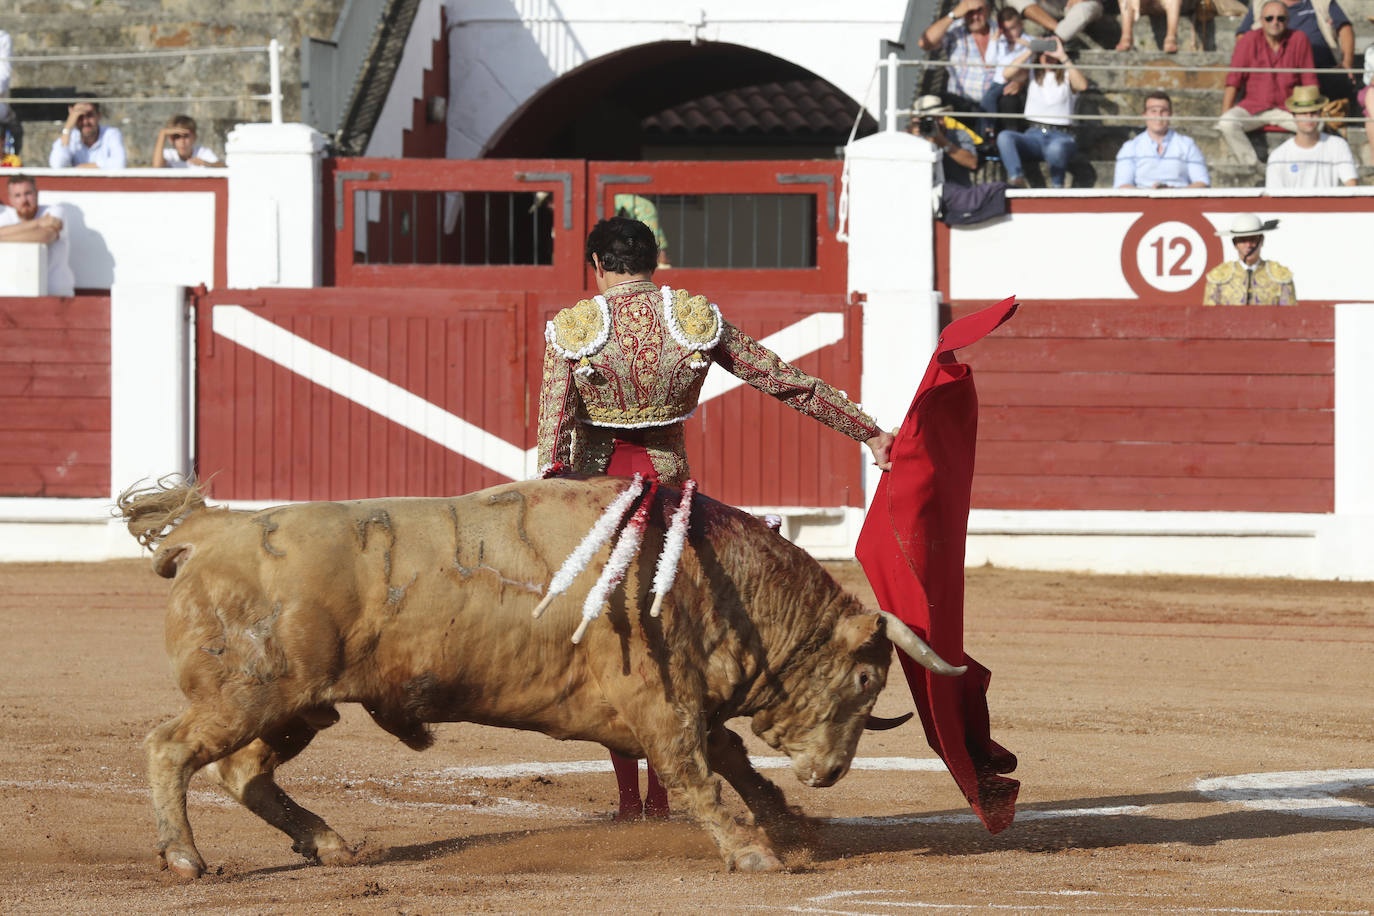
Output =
[{"x1": 224, "y1": 124, "x2": 324, "y2": 288}]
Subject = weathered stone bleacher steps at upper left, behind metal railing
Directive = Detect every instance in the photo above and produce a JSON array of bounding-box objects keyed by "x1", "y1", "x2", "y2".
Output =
[{"x1": 0, "y1": 0, "x2": 345, "y2": 166}]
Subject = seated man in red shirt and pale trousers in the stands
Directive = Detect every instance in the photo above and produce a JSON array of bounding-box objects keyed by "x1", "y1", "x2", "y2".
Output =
[{"x1": 1216, "y1": 0, "x2": 1316, "y2": 165}]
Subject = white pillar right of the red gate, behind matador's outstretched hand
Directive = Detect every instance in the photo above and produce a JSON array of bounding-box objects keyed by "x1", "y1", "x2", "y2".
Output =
[{"x1": 845, "y1": 132, "x2": 940, "y2": 501}]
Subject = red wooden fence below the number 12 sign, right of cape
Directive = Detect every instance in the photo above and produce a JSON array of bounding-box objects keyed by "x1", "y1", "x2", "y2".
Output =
[{"x1": 954, "y1": 304, "x2": 1334, "y2": 512}]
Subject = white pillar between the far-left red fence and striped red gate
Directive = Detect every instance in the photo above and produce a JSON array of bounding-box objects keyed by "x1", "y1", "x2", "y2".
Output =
[{"x1": 110, "y1": 283, "x2": 191, "y2": 530}]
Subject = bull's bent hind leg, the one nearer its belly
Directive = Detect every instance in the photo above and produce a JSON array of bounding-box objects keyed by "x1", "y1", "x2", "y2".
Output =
[{"x1": 209, "y1": 709, "x2": 356, "y2": 865}]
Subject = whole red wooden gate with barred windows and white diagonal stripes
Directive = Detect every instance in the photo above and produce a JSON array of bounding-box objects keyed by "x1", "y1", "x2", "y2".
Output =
[{"x1": 196, "y1": 159, "x2": 863, "y2": 507}]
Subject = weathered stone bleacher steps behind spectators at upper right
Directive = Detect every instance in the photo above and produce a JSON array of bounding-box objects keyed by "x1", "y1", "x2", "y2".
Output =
[{"x1": 1000, "y1": 0, "x2": 1374, "y2": 188}]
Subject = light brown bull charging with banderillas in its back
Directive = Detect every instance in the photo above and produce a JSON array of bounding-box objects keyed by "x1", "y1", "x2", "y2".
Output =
[{"x1": 120, "y1": 478, "x2": 962, "y2": 878}]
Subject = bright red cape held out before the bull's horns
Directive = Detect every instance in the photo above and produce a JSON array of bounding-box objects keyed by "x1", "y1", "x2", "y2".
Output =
[{"x1": 855, "y1": 299, "x2": 1021, "y2": 834}]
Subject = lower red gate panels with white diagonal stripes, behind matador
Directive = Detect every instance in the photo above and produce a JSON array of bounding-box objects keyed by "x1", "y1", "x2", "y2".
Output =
[{"x1": 196, "y1": 290, "x2": 863, "y2": 507}]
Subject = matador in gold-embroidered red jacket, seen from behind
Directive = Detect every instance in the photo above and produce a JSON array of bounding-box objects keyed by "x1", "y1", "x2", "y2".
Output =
[{"x1": 539, "y1": 217, "x2": 892, "y2": 820}]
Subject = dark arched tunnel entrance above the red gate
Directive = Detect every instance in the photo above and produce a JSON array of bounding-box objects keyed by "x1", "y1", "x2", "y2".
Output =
[{"x1": 484, "y1": 41, "x2": 877, "y2": 161}]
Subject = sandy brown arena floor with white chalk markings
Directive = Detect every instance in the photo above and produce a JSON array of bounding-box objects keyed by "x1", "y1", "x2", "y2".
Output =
[{"x1": 0, "y1": 562, "x2": 1374, "y2": 916}]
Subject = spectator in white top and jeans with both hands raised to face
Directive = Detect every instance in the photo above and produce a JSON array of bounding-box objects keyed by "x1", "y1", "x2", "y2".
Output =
[{"x1": 998, "y1": 36, "x2": 1088, "y2": 188}]
